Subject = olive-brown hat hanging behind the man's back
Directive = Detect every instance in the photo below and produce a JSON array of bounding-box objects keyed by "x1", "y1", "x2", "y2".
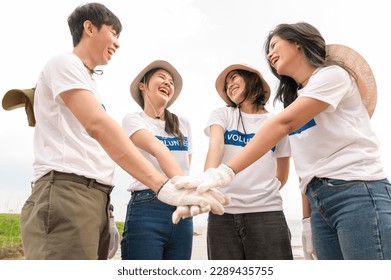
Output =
[{"x1": 2, "y1": 88, "x2": 35, "y2": 126}]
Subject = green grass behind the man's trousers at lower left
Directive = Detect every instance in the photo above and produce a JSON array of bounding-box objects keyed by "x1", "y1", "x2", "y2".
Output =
[{"x1": 0, "y1": 214, "x2": 124, "y2": 259}]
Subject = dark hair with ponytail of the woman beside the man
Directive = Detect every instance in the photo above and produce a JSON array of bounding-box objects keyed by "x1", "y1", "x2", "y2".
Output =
[{"x1": 140, "y1": 68, "x2": 185, "y2": 146}]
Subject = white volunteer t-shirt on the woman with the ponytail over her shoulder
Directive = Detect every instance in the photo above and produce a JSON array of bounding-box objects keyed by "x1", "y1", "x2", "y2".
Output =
[{"x1": 122, "y1": 112, "x2": 193, "y2": 191}]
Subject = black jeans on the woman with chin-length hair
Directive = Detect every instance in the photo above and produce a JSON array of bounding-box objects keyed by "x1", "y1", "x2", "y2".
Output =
[{"x1": 207, "y1": 211, "x2": 293, "y2": 260}]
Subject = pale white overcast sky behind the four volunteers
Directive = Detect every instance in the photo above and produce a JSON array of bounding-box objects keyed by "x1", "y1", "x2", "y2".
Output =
[{"x1": 0, "y1": 0, "x2": 391, "y2": 224}]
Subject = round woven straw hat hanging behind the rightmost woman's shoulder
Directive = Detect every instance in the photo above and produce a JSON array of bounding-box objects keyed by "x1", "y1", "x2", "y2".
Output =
[{"x1": 326, "y1": 44, "x2": 377, "y2": 117}]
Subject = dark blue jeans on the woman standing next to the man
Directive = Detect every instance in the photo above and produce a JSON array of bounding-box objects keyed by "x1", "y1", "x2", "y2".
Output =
[{"x1": 121, "y1": 190, "x2": 193, "y2": 260}]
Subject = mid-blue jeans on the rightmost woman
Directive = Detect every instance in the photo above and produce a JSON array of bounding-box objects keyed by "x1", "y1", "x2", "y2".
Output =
[{"x1": 306, "y1": 178, "x2": 391, "y2": 260}]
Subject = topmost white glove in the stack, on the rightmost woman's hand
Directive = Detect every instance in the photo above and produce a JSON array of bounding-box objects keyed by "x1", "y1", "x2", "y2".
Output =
[{"x1": 171, "y1": 164, "x2": 235, "y2": 193}]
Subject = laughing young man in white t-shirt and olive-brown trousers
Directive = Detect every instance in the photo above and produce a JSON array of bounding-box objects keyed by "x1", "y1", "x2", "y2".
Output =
[{"x1": 21, "y1": 3, "x2": 227, "y2": 259}]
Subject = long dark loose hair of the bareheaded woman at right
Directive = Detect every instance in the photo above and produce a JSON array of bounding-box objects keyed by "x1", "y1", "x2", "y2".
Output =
[{"x1": 264, "y1": 22, "x2": 354, "y2": 108}]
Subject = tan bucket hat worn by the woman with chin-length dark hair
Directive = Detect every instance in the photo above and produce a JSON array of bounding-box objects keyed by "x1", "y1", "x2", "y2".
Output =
[{"x1": 215, "y1": 64, "x2": 270, "y2": 106}]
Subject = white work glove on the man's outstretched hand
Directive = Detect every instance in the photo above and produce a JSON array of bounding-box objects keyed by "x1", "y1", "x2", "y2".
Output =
[{"x1": 157, "y1": 180, "x2": 230, "y2": 213}]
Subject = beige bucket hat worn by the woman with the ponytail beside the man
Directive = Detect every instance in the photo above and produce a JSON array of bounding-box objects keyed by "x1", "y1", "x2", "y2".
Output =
[{"x1": 130, "y1": 60, "x2": 183, "y2": 108}]
